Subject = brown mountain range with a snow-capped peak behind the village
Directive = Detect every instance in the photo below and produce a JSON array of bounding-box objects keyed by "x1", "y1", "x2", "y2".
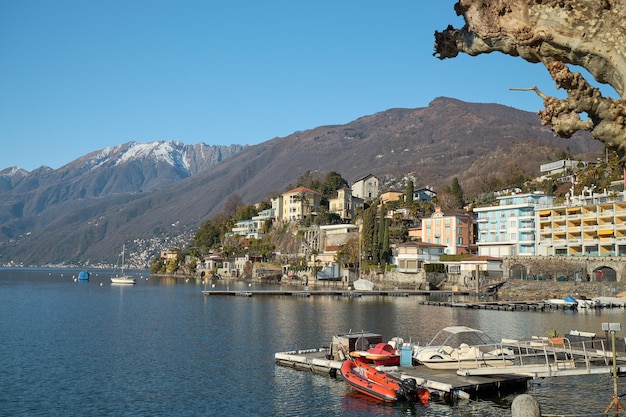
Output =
[{"x1": 0, "y1": 97, "x2": 604, "y2": 266}]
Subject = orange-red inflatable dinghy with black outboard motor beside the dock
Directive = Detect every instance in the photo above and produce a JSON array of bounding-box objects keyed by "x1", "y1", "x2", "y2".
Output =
[{"x1": 341, "y1": 359, "x2": 430, "y2": 402}]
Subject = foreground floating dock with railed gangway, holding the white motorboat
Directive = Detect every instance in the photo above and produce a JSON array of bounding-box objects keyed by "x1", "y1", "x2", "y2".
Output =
[{"x1": 274, "y1": 331, "x2": 626, "y2": 402}]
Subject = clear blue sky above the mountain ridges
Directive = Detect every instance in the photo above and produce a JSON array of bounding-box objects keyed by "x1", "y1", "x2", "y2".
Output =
[{"x1": 0, "y1": 0, "x2": 576, "y2": 170}]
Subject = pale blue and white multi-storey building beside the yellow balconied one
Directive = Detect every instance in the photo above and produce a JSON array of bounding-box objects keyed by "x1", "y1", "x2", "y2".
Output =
[{"x1": 474, "y1": 191, "x2": 554, "y2": 258}]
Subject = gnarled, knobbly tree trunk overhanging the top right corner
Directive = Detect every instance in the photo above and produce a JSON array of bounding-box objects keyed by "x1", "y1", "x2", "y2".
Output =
[{"x1": 434, "y1": 0, "x2": 626, "y2": 158}]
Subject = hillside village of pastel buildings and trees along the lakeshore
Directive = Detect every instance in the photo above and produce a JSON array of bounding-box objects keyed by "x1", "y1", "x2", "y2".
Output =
[{"x1": 151, "y1": 156, "x2": 626, "y2": 289}]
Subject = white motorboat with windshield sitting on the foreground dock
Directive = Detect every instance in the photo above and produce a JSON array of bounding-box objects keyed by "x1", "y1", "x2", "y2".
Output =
[{"x1": 414, "y1": 326, "x2": 514, "y2": 369}]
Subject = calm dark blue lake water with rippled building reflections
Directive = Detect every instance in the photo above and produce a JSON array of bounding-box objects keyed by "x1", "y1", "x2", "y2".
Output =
[{"x1": 0, "y1": 269, "x2": 626, "y2": 417}]
